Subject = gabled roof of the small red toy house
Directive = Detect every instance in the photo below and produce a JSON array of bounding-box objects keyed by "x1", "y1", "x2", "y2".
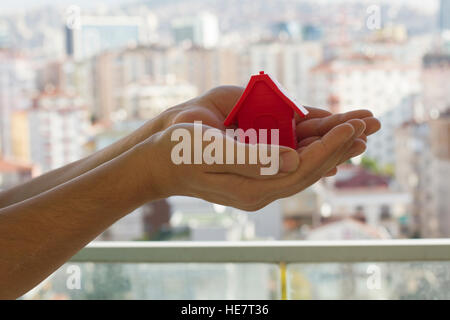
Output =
[{"x1": 224, "y1": 71, "x2": 308, "y2": 126}]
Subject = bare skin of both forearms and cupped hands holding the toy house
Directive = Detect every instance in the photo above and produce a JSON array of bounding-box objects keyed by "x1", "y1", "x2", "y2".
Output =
[{"x1": 0, "y1": 87, "x2": 380, "y2": 299}]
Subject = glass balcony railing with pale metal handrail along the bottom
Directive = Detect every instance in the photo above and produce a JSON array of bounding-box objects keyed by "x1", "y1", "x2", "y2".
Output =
[{"x1": 23, "y1": 239, "x2": 450, "y2": 299}]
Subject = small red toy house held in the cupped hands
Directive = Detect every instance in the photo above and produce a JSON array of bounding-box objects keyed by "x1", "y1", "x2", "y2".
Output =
[{"x1": 224, "y1": 71, "x2": 308, "y2": 149}]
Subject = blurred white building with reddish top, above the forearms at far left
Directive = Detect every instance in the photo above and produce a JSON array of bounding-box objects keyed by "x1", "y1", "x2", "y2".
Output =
[{"x1": 28, "y1": 91, "x2": 89, "y2": 172}]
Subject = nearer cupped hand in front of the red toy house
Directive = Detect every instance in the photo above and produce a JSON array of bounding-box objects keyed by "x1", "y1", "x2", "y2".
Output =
[{"x1": 142, "y1": 119, "x2": 366, "y2": 211}]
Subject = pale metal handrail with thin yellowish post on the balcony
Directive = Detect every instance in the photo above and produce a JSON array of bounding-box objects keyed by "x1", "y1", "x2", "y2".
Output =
[{"x1": 71, "y1": 239, "x2": 450, "y2": 299}]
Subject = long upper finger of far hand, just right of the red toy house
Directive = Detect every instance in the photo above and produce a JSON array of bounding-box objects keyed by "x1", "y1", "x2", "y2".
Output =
[{"x1": 296, "y1": 110, "x2": 373, "y2": 140}]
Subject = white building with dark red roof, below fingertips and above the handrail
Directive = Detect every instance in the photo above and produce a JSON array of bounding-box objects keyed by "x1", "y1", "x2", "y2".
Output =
[{"x1": 318, "y1": 166, "x2": 412, "y2": 238}]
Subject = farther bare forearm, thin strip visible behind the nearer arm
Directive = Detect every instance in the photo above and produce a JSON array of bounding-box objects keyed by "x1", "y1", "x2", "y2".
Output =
[{"x1": 0, "y1": 110, "x2": 170, "y2": 208}]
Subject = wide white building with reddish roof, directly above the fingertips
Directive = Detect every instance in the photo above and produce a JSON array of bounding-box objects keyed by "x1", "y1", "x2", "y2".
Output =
[{"x1": 311, "y1": 55, "x2": 420, "y2": 116}]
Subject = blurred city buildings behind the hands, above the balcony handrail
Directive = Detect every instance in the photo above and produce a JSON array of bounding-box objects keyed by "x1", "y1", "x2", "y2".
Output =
[{"x1": 0, "y1": 0, "x2": 450, "y2": 245}]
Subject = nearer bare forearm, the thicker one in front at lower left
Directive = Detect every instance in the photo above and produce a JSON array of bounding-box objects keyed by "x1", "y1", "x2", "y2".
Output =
[{"x1": 0, "y1": 139, "x2": 158, "y2": 298}]
